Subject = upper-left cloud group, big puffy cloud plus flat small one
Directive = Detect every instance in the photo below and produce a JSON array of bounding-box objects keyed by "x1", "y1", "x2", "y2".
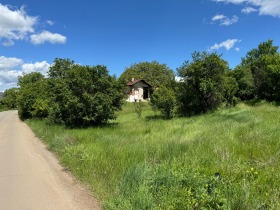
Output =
[{"x1": 0, "y1": 3, "x2": 66, "y2": 47}]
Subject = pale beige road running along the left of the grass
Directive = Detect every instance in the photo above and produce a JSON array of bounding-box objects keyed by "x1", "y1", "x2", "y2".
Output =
[{"x1": 0, "y1": 111, "x2": 100, "y2": 210}]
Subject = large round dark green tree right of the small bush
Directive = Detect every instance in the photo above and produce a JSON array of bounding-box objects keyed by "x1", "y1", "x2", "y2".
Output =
[{"x1": 178, "y1": 52, "x2": 234, "y2": 115}]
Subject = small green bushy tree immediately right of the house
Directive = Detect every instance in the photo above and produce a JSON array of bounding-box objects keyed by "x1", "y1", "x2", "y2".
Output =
[{"x1": 151, "y1": 86, "x2": 176, "y2": 118}]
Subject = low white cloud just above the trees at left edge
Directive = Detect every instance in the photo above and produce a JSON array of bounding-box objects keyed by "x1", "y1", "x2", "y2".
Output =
[{"x1": 0, "y1": 56, "x2": 50, "y2": 92}]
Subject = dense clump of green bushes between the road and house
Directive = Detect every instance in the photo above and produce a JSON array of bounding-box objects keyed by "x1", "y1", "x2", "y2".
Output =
[{"x1": 12, "y1": 59, "x2": 123, "y2": 127}]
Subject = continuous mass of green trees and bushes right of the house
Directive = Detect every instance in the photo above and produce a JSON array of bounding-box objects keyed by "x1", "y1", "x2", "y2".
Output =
[{"x1": 151, "y1": 40, "x2": 280, "y2": 117}]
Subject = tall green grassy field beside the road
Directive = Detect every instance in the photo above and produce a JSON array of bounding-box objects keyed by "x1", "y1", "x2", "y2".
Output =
[{"x1": 28, "y1": 102, "x2": 280, "y2": 210}]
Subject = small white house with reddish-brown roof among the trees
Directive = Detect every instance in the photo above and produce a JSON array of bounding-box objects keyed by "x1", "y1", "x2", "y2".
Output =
[{"x1": 126, "y1": 78, "x2": 152, "y2": 102}]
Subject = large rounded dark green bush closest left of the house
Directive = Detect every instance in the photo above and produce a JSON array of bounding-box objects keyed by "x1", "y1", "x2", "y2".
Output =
[{"x1": 49, "y1": 59, "x2": 123, "y2": 127}]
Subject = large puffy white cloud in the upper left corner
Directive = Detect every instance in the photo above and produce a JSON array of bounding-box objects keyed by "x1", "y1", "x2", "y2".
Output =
[{"x1": 0, "y1": 3, "x2": 38, "y2": 46}]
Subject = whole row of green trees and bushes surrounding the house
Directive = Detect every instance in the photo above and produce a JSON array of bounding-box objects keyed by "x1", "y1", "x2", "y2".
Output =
[{"x1": 1, "y1": 40, "x2": 280, "y2": 124}]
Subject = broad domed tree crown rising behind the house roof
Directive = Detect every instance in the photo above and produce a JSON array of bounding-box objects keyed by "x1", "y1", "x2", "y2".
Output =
[{"x1": 119, "y1": 61, "x2": 175, "y2": 90}]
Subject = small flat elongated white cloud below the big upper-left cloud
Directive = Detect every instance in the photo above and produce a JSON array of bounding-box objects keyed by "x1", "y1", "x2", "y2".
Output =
[{"x1": 30, "y1": 31, "x2": 66, "y2": 45}]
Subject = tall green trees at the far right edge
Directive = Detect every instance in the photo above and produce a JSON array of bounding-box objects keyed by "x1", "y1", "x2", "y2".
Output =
[{"x1": 233, "y1": 40, "x2": 280, "y2": 100}]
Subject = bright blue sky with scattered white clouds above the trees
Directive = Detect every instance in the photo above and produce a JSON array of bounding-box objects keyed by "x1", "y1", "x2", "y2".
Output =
[{"x1": 0, "y1": 0, "x2": 280, "y2": 91}]
